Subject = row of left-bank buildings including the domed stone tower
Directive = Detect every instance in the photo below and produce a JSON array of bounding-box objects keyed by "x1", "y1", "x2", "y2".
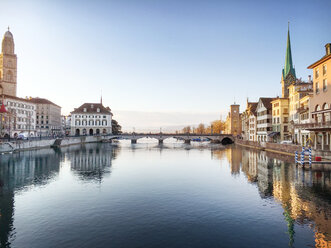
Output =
[{"x1": 0, "y1": 29, "x2": 113, "y2": 138}]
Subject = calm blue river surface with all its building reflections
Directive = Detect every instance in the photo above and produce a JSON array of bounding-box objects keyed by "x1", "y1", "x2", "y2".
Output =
[{"x1": 0, "y1": 142, "x2": 331, "y2": 248}]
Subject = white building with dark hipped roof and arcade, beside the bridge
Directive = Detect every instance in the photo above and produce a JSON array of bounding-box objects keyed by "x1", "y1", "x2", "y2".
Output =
[{"x1": 70, "y1": 102, "x2": 113, "y2": 135}]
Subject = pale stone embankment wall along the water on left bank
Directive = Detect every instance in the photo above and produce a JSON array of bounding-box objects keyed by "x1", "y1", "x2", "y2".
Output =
[{"x1": 0, "y1": 136, "x2": 103, "y2": 153}]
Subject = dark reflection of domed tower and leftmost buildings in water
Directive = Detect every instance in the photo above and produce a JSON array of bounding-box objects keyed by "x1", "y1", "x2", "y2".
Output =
[{"x1": 0, "y1": 149, "x2": 61, "y2": 247}]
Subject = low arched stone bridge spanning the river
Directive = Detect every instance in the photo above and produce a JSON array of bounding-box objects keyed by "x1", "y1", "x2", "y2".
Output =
[{"x1": 104, "y1": 133, "x2": 235, "y2": 145}]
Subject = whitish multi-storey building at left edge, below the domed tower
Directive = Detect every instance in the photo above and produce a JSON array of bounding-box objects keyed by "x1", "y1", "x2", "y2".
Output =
[{"x1": 0, "y1": 95, "x2": 36, "y2": 137}]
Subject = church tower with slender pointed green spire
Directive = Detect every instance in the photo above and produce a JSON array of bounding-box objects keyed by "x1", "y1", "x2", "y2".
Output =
[{"x1": 281, "y1": 24, "x2": 296, "y2": 98}]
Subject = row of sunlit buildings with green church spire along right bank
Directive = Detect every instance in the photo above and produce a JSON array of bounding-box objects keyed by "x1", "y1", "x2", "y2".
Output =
[{"x1": 225, "y1": 27, "x2": 331, "y2": 151}]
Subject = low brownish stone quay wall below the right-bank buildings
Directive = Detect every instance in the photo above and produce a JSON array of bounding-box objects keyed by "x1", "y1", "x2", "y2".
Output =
[{"x1": 235, "y1": 139, "x2": 331, "y2": 160}]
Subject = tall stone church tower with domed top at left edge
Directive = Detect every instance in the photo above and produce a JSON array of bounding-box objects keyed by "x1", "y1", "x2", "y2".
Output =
[{"x1": 0, "y1": 28, "x2": 17, "y2": 96}]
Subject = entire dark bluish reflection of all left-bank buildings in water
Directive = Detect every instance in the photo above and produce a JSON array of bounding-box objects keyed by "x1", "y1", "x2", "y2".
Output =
[{"x1": 0, "y1": 144, "x2": 119, "y2": 247}]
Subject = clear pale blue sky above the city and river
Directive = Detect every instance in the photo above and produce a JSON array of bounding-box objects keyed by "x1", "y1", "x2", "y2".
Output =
[{"x1": 0, "y1": 0, "x2": 331, "y2": 130}]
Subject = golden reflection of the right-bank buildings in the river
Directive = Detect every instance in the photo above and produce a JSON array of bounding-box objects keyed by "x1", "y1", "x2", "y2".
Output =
[{"x1": 212, "y1": 148, "x2": 331, "y2": 247}]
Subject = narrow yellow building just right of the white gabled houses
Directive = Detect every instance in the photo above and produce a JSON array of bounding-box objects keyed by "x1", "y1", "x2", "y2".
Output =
[{"x1": 269, "y1": 98, "x2": 290, "y2": 142}]
